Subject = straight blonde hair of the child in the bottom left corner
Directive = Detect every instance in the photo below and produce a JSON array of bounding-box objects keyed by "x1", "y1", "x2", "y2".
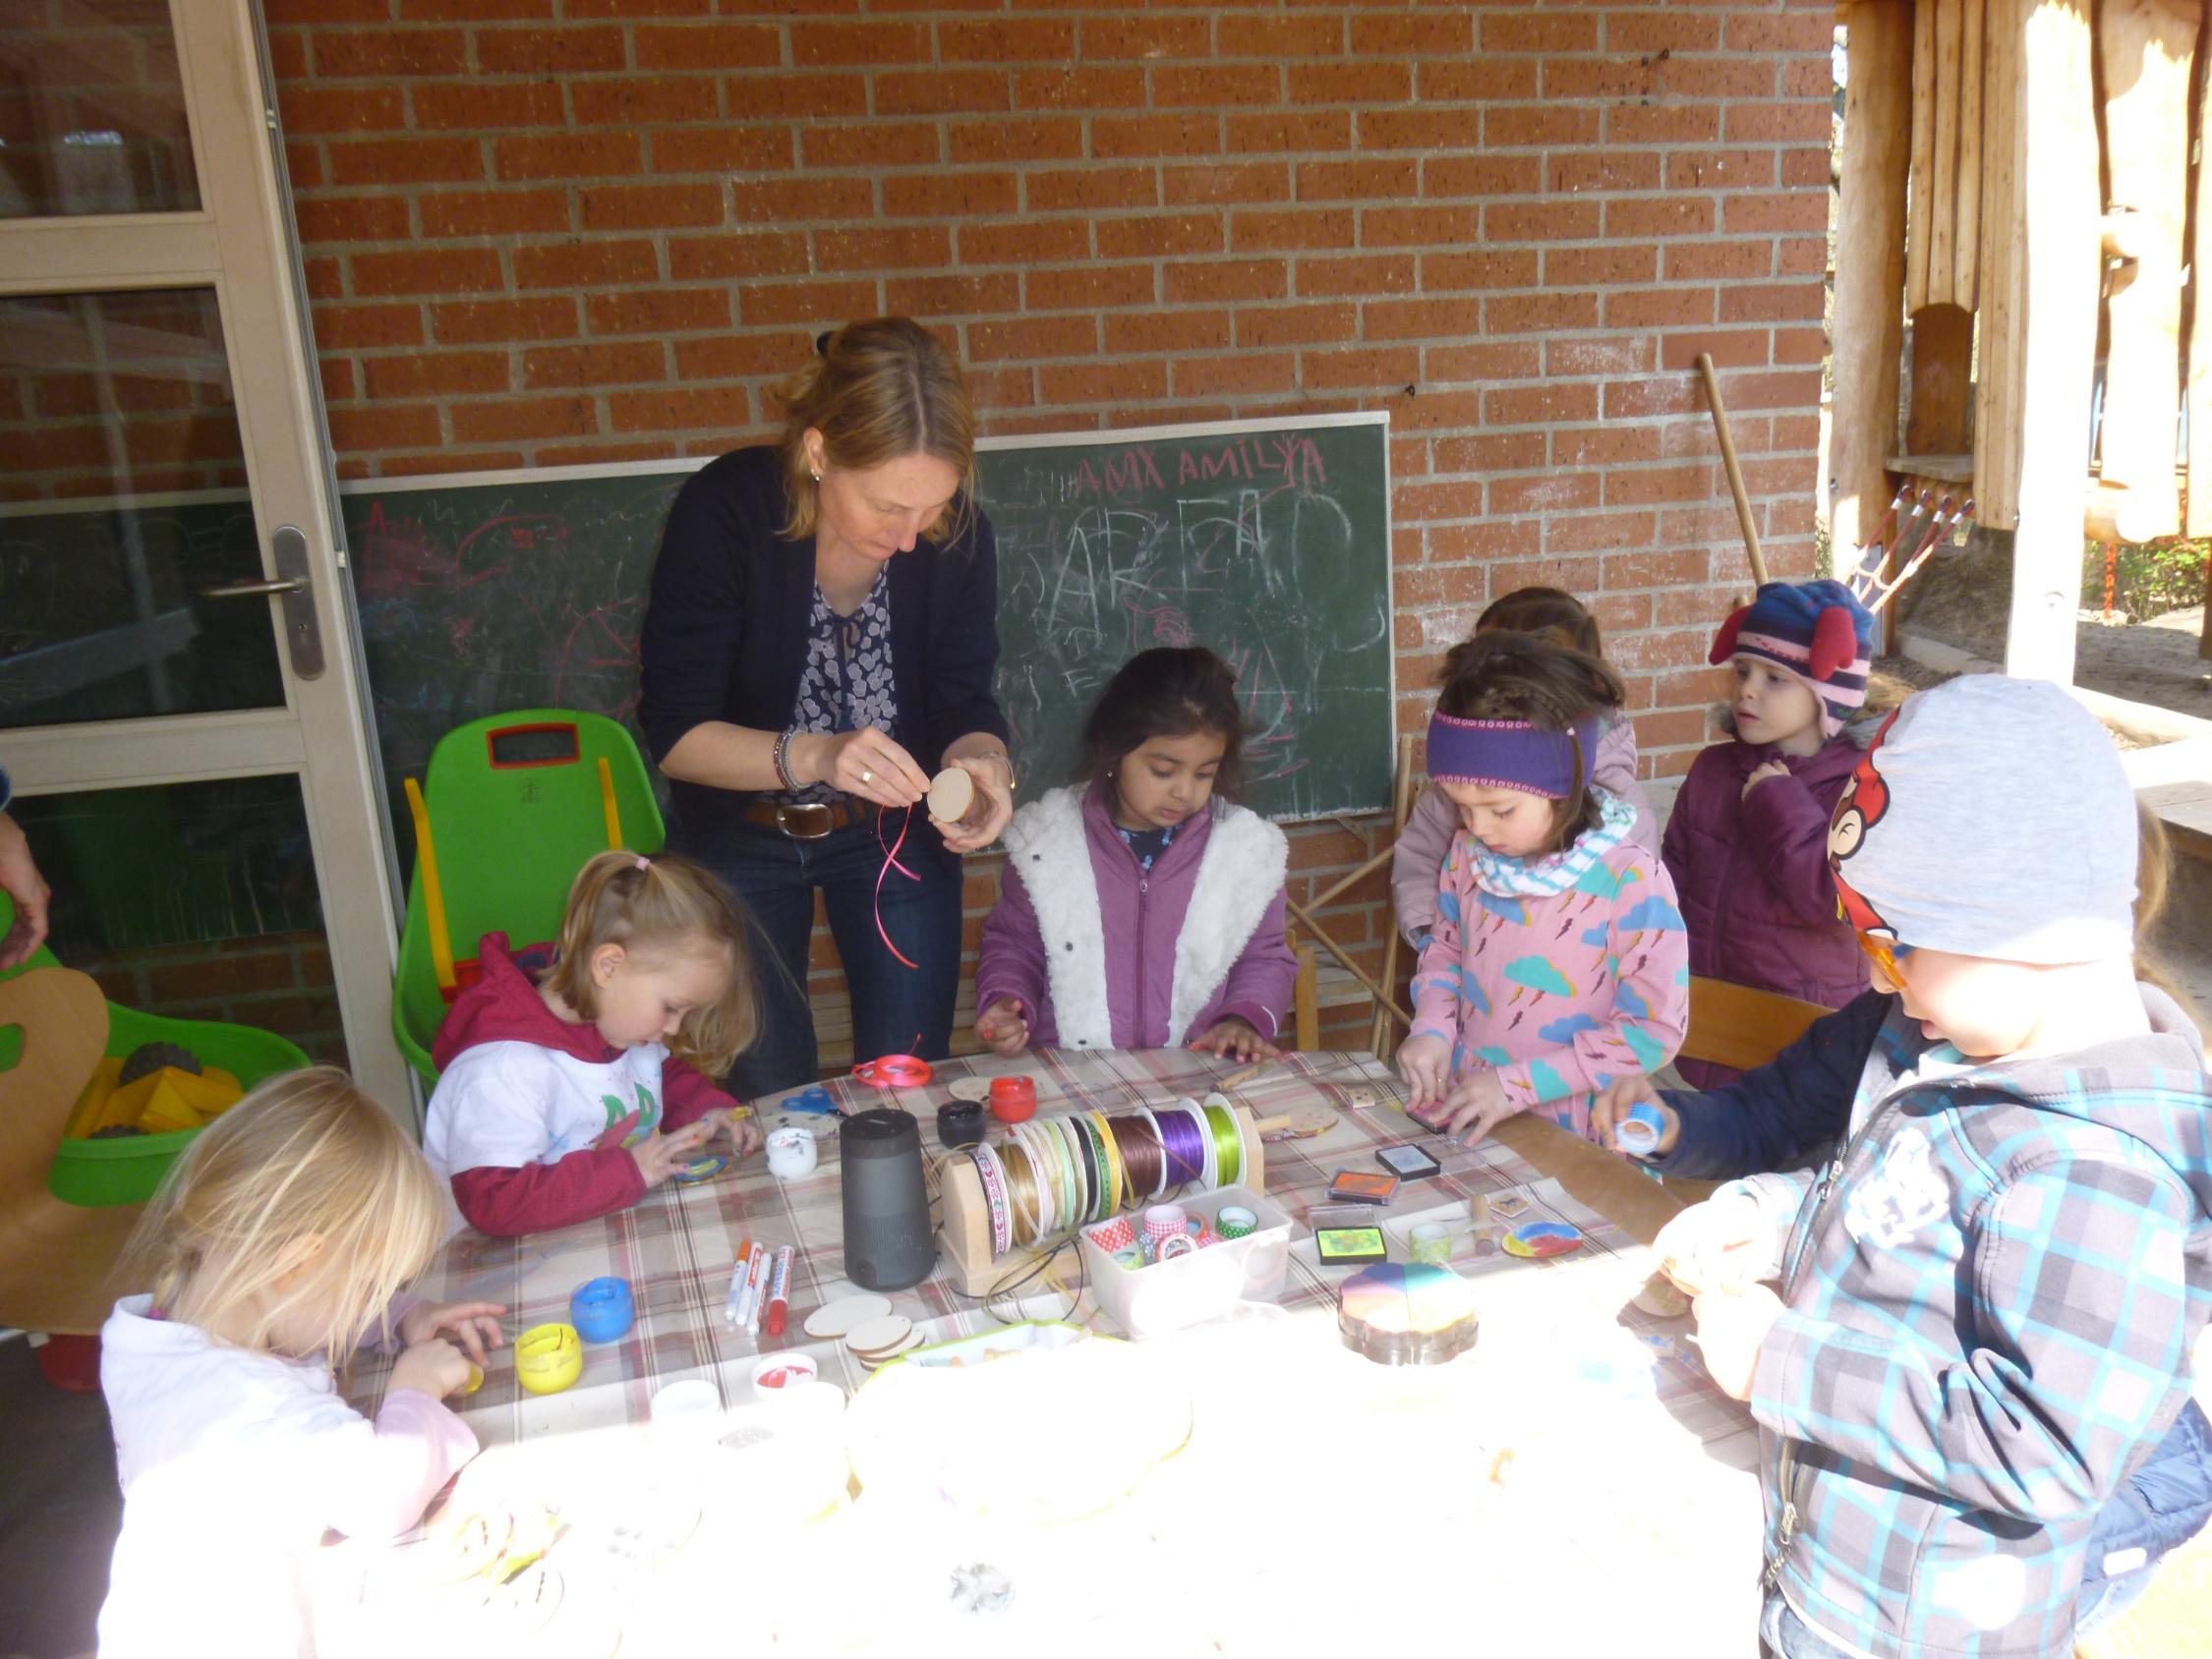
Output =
[{"x1": 115, "y1": 1066, "x2": 447, "y2": 1362}]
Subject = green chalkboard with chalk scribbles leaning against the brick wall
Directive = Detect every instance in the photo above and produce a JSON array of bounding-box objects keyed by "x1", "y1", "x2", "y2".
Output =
[{"x1": 343, "y1": 416, "x2": 1391, "y2": 836}]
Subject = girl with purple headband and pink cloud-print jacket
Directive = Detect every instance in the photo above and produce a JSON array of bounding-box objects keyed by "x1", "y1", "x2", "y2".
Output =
[{"x1": 1398, "y1": 633, "x2": 1690, "y2": 1139}]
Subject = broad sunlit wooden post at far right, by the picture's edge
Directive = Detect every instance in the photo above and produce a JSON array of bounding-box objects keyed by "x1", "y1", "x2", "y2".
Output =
[{"x1": 2097, "y1": 0, "x2": 2199, "y2": 540}]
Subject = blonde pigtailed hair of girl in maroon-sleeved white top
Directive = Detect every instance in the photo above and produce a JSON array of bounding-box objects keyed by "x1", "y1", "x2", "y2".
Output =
[{"x1": 545, "y1": 852, "x2": 759, "y2": 1077}]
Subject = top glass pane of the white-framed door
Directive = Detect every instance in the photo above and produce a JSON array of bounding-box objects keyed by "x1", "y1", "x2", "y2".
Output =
[{"x1": 0, "y1": 0, "x2": 200, "y2": 219}]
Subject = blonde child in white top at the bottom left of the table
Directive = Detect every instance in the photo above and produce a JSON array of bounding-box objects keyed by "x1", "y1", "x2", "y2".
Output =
[{"x1": 99, "y1": 1068, "x2": 504, "y2": 1659}]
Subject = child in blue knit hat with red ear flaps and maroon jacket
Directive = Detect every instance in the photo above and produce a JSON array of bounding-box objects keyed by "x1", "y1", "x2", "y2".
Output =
[{"x1": 1661, "y1": 582, "x2": 1874, "y2": 1088}]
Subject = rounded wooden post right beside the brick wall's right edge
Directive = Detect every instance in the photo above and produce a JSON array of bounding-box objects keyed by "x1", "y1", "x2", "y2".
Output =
[{"x1": 1828, "y1": 0, "x2": 1913, "y2": 566}]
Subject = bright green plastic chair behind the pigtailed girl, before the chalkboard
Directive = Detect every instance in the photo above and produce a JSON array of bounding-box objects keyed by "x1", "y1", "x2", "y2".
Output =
[{"x1": 391, "y1": 708, "x2": 669, "y2": 1088}]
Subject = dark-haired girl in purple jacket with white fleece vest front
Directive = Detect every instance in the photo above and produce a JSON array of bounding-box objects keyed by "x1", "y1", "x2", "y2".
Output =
[{"x1": 975, "y1": 646, "x2": 1299, "y2": 1059}]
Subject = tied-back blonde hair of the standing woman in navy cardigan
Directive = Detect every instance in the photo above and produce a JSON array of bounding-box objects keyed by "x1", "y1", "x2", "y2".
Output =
[{"x1": 772, "y1": 316, "x2": 975, "y2": 542}]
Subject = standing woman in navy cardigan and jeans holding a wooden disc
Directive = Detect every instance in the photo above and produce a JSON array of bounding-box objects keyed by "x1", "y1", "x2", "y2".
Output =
[{"x1": 639, "y1": 316, "x2": 1014, "y2": 1097}]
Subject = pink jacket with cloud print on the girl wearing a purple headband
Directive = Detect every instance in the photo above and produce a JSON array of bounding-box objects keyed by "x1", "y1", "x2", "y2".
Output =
[{"x1": 1412, "y1": 807, "x2": 1690, "y2": 1135}]
